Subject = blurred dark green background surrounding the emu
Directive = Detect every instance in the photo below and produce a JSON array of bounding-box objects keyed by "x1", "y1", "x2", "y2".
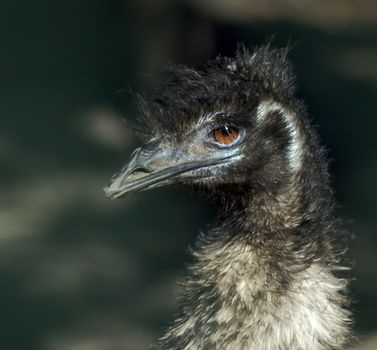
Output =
[{"x1": 0, "y1": 0, "x2": 377, "y2": 350}]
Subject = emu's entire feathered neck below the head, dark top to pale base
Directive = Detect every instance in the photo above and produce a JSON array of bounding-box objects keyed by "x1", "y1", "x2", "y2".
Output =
[{"x1": 155, "y1": 174, "x2": 350, "y2": 350}]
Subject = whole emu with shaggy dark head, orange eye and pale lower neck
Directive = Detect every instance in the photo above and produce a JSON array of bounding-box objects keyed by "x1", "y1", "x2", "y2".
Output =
[{"x1": 105, "y1": 45, "x2": 351, "y2": 350}]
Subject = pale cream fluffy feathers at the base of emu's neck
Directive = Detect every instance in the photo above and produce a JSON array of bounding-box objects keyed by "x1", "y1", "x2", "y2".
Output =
[{"x1": 159, "y1": 241, "x2": 349, "y2": 350}]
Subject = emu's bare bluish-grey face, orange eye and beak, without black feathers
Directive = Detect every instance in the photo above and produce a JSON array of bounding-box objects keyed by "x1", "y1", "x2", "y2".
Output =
[{"x1": 105, "y1": 113, "x2": 246, "y2": 198}]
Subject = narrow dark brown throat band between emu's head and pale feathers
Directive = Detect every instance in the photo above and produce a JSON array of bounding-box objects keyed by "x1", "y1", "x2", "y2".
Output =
[{"x1": 218, "y1": 175, "x2": 312, "y2": 238}]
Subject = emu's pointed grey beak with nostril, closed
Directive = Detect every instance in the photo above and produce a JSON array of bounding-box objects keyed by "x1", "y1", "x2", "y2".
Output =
[{"x1": 104, "y1": 141, "x2": 229, "y2": 199}]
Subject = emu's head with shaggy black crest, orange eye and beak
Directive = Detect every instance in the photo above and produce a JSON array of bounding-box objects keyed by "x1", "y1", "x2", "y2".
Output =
[{"x1": 105, "y1": 46, "x2": 304, "y2": 198}]
